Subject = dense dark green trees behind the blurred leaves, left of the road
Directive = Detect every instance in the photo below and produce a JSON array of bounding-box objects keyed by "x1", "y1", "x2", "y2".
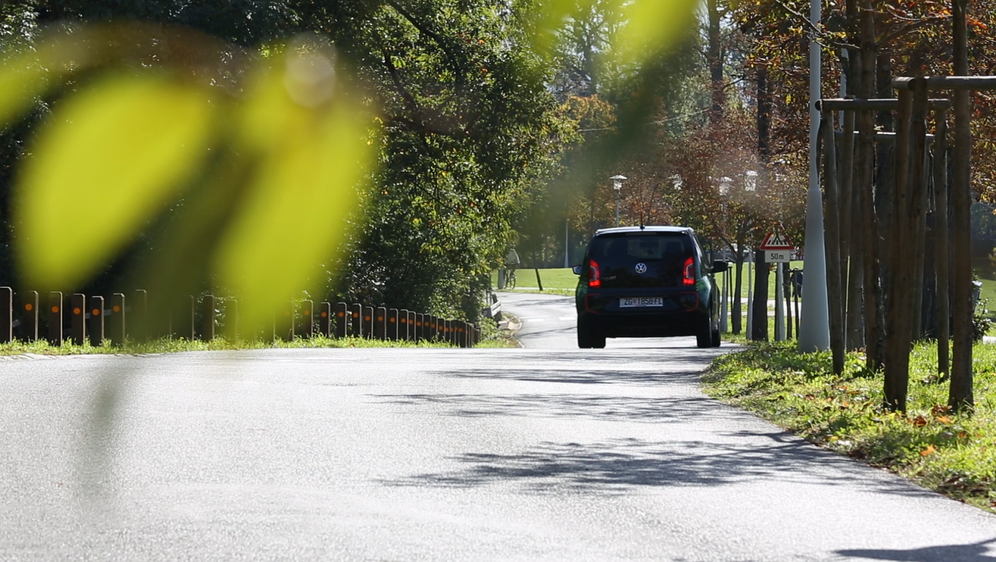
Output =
[{"x1": 3, "y1": 0, "x2": 564, "y2": 317}]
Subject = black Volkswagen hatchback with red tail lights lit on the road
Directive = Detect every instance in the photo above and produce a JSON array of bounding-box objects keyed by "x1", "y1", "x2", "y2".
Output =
[{"x1": 574, "y1": 226, "x2": 727, "y2": 348}]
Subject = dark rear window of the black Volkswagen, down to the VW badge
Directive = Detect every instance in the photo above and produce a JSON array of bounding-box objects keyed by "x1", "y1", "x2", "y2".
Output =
[{"x1": 588, "y1": 232, "x2": 693, "y2": 289}]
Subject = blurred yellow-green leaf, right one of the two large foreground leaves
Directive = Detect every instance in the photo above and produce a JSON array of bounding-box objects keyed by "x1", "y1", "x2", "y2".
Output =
[{"x1": 214, "y1": 50, "x2": 373, "y2": 326}]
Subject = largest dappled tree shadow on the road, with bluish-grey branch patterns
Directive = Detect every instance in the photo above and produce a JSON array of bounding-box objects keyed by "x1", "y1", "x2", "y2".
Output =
[{"x1": 382, "y1": 434, "x2": 933, "y2": 497}]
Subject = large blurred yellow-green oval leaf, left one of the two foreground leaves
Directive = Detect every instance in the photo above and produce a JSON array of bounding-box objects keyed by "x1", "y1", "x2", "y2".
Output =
[{"x1": 15, "y1": 76, "x2": 214, "y2": 287}]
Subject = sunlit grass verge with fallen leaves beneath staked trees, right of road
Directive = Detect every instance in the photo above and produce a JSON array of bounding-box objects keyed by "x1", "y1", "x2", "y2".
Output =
[{"x1": 705, "y1": 342, "x2": 996, "y2": 511}]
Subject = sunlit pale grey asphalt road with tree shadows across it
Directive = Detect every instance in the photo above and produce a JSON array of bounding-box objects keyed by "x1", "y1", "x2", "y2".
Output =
[{"x1": 0, "y1": 290, "x2": 996, "y2": 561}]
